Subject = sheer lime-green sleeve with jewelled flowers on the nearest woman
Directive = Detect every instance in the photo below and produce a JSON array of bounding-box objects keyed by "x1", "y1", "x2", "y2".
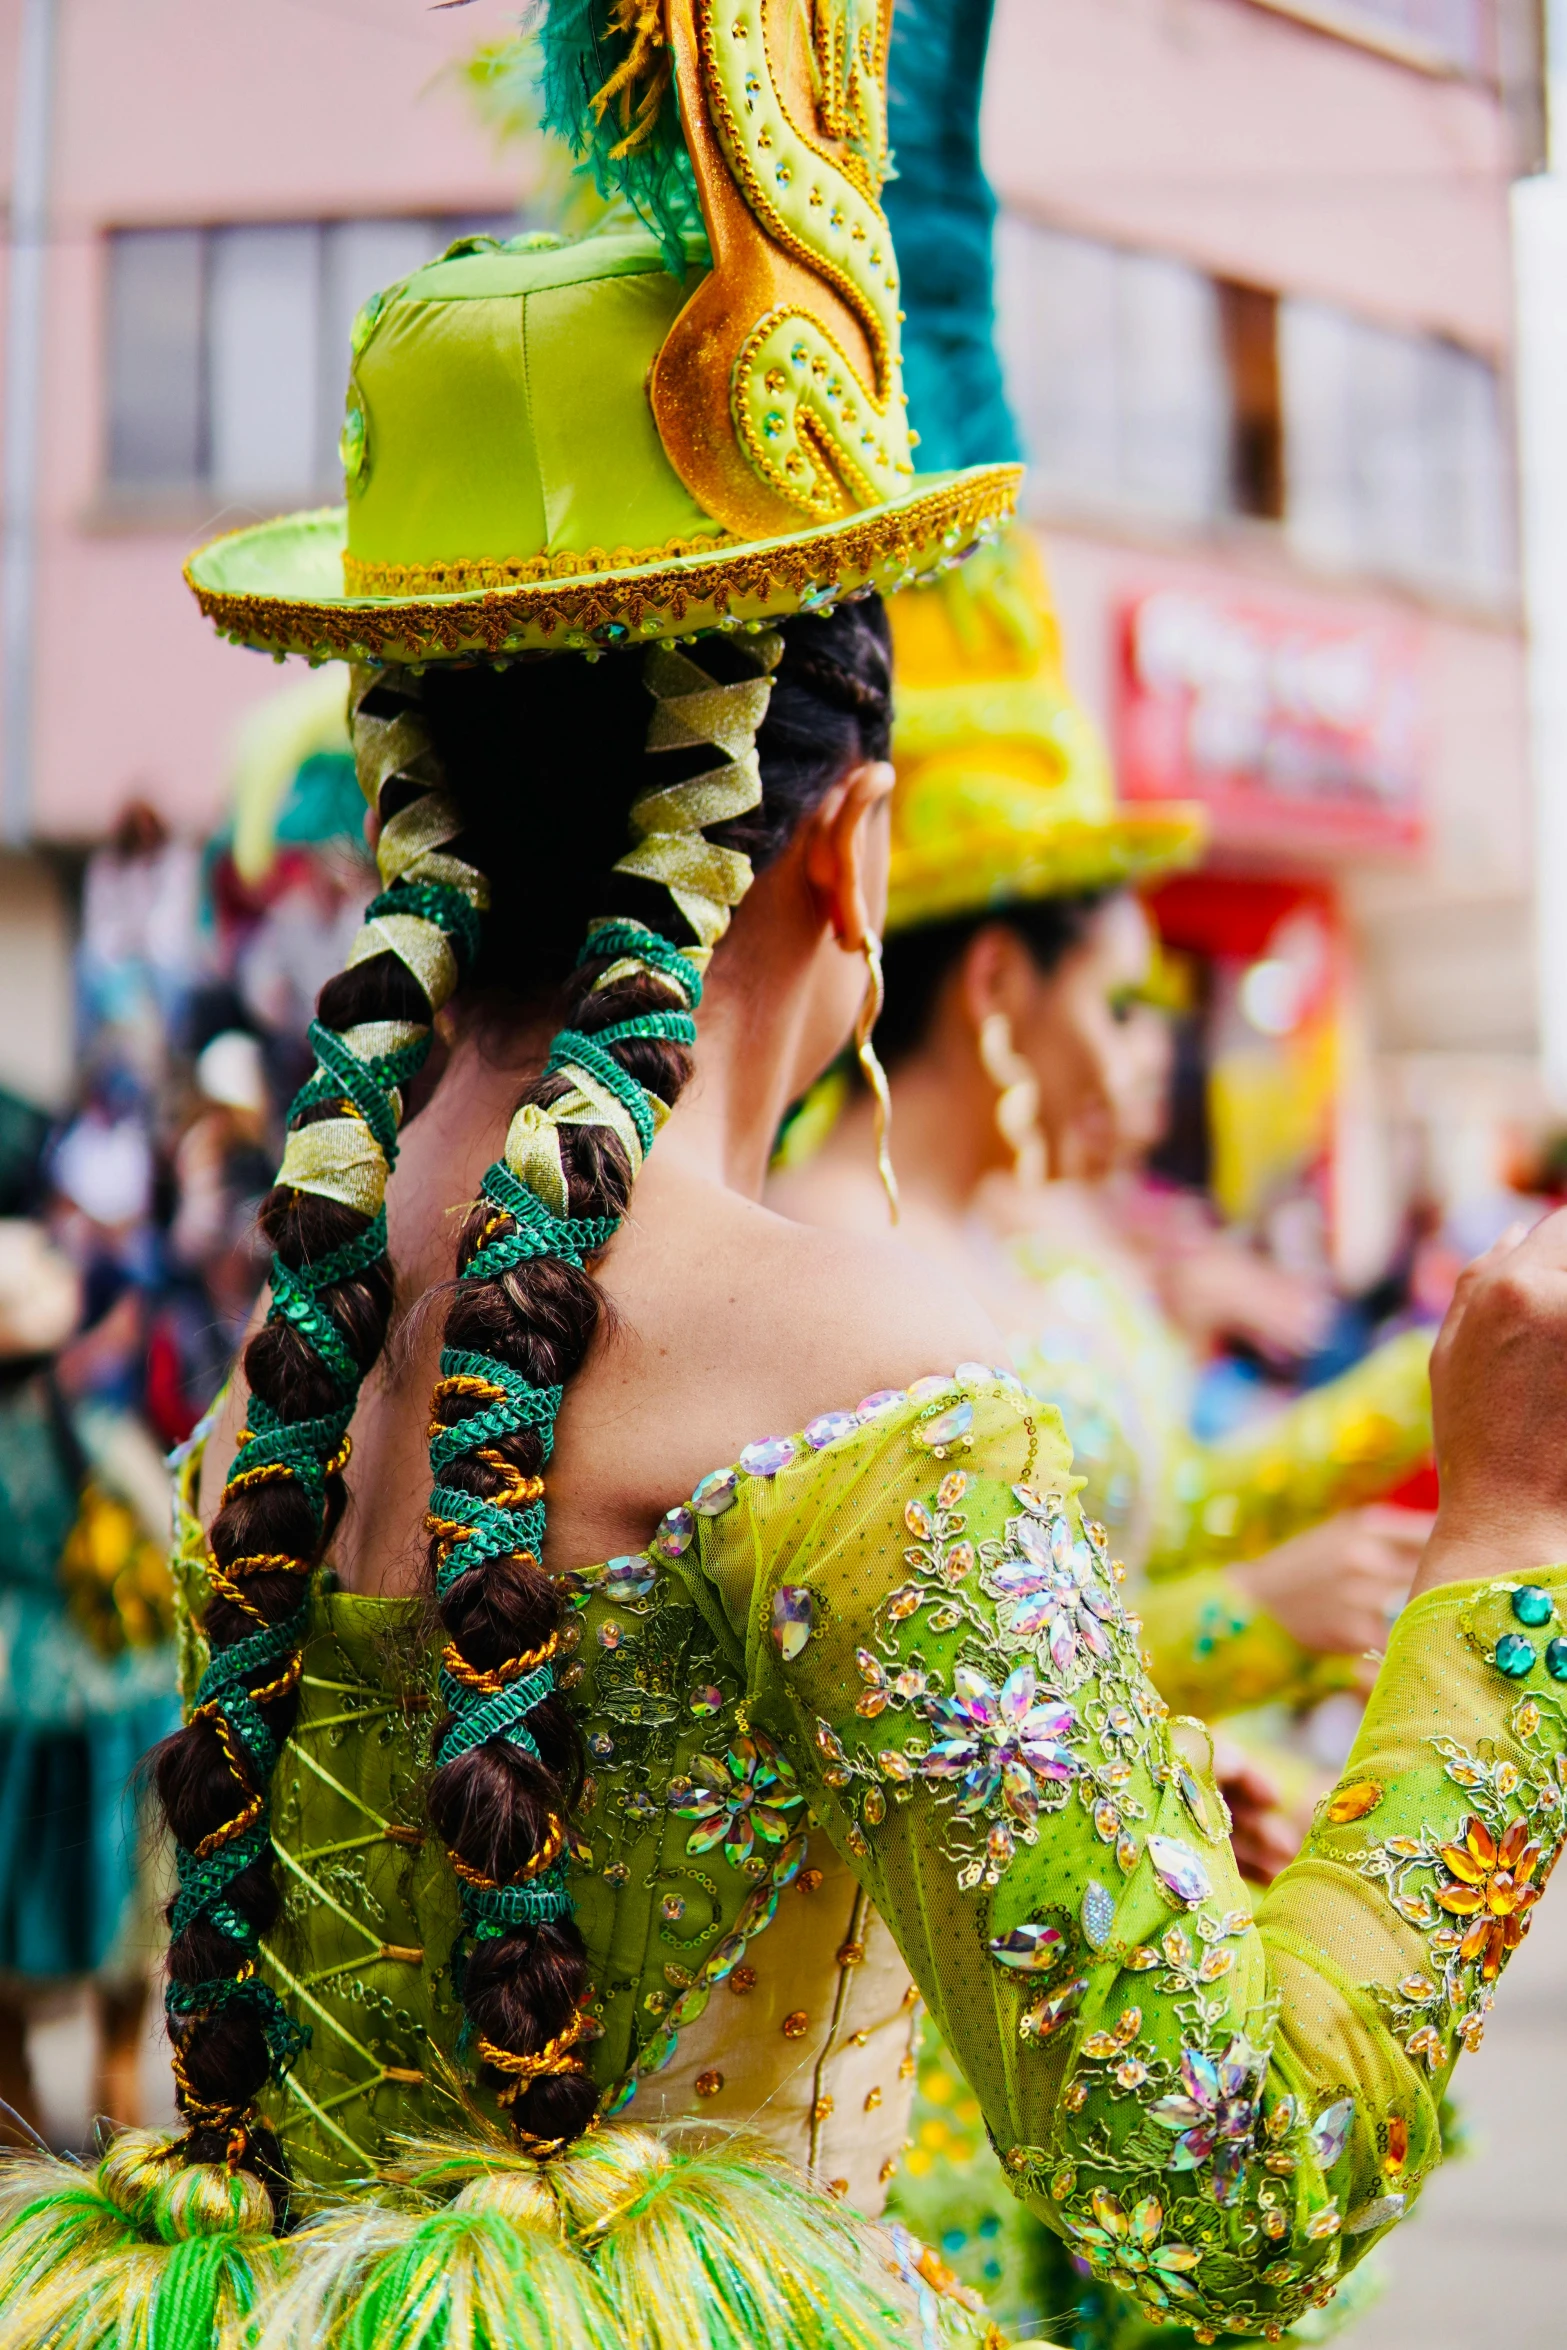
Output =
[{"x1": 700, "y1": 1375, "x2": 1567, "y2": 2341}]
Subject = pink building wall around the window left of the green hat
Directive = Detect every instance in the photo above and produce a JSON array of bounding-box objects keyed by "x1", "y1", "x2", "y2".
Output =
[{"x1": 0, "y1": 0, "x2": 526, "y2": 841}]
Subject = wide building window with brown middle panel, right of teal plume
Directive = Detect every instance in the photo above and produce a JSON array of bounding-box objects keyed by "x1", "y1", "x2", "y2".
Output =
[{"x1": 996, "y1": 216, "x2": 1515, "y2": 602}]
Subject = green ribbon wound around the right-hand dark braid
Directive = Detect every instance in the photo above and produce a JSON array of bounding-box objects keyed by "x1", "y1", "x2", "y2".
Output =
[{"x1": 430, "y1": 921, "x2": 702, "y2": 1972}]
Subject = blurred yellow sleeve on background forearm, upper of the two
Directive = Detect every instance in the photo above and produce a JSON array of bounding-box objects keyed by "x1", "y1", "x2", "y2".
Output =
[{"x1": 1146, "y1": 1330, "x2": 1431, "y2": 1577}]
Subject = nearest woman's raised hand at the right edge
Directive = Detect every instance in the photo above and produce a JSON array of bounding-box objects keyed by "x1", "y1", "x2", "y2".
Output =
[{"x1": 1414, "y1": 1210, "x2": 1567, "y2": 1591}]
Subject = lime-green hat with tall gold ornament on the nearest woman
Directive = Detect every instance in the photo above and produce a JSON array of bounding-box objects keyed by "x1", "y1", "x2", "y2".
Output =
[{"x1": 186, "y1": 0, "x2": 1020, "y2": 663}]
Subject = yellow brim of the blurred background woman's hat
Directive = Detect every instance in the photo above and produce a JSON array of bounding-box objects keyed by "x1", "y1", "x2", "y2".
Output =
[{"x1": 886, "y1": 799, "x2": 1208, "y2": 935}]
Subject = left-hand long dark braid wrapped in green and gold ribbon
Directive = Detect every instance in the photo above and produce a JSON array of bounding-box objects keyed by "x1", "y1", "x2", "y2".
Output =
[{"x1": 155, "y1": 672, "x2": 486, "y2": 2216}]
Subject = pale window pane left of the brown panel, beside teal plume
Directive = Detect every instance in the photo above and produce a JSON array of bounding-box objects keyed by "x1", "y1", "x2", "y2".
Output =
[{"x1": 996, "y1": 214, "x2": 1231, "y2": 522}]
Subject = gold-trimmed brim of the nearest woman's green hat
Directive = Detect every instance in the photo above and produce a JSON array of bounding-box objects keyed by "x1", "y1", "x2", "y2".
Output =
[{"x1": 186, "y1": 465, "x2": 1022, "y2": 663}]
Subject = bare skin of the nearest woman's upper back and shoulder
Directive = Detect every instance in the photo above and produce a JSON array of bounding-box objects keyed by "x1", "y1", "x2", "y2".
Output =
[{"x1": 202, "y1": 1036, "x2": 1003, "y2": 1593}]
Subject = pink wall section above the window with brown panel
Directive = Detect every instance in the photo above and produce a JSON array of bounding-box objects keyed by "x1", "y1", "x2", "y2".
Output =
[{"x1": 984, "y1": 0, "x2": 1515, "y2": 350}]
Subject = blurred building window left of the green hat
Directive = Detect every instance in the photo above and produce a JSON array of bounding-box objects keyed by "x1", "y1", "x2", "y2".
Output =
[{"x1": 108, "y1": 216, "x2": 515, "y2": 508}]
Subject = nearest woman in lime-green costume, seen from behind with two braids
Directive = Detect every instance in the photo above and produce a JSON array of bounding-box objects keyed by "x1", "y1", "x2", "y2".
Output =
[{"x1": 0, "y1": 0, "x2": 1567, "y2": 2350}]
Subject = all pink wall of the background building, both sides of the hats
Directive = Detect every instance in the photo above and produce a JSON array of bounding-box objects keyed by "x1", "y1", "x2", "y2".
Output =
[{"x1": 0, "y1": 0, "x2": 1532, "y2": 1090}]
